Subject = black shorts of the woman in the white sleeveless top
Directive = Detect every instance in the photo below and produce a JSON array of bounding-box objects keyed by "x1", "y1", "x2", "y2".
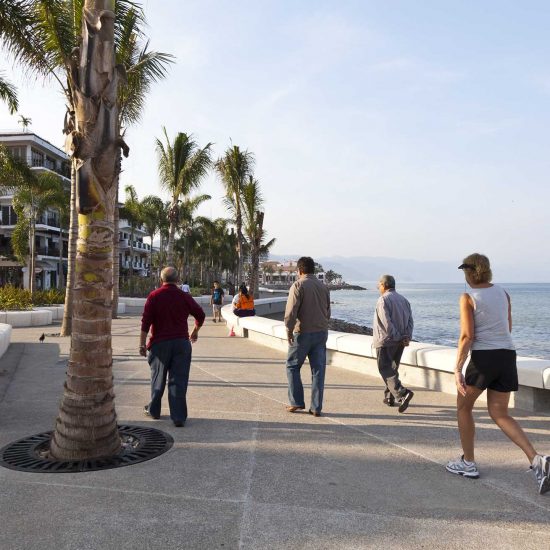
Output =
[{"x1": 464, "y1": 349, "x2": 518, "y2": 392}]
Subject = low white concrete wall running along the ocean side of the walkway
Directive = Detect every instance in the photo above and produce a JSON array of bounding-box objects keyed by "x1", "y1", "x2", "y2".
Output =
[{"x1": 222, "y1": 298, "x2": 550, "y2": 413}]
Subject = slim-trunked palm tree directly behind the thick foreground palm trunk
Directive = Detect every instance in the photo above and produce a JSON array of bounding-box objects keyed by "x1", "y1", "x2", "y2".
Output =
[{"x1": 0, "y1": 0, "x2": 173, "y2": 336}]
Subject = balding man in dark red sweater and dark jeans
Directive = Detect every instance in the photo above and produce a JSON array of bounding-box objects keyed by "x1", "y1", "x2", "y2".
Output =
[{"x1": 139, "y1": 267, "x2": 205, "y2": 427}]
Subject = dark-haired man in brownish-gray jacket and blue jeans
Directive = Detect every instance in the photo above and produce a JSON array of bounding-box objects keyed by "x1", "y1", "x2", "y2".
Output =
[{"x1": 285, "y1": 257, "x2": 330, "y2": 416}]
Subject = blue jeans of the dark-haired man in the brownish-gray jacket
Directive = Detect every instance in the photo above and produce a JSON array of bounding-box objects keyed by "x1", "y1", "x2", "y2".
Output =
[{"x1": 286, "y1": 330, "x2": 328, "y2": 412}]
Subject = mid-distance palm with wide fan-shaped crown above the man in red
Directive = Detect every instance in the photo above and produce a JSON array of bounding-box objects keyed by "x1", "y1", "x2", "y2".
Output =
[{"x1": 156, "y1": 128, "x2": 216, "y2": 265}]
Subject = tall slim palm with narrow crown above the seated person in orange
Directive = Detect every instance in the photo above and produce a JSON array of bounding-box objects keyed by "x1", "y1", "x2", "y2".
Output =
[{"x1": 215, "y1": 145, "x2": 254, "y2": 284}]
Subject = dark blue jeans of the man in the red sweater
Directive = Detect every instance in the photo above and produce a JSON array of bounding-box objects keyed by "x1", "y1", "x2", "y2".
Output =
[{"x1": 147, "y1": 338, "x2": 191, "y2": 422}]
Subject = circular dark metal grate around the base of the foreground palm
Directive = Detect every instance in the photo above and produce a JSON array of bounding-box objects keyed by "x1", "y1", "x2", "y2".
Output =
[{"x1": 0, "y1": 426, "x2": 174, "y2": 474}]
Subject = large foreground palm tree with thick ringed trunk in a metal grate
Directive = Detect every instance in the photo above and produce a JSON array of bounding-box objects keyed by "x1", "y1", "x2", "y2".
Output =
[{"x1": 0, "y1": 0, "x2": 174, "y2": 459}]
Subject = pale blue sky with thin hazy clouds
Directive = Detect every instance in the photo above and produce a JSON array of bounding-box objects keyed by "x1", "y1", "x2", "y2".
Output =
[{"x1": 0, "y1": 0, "x2": 550, "y2": 281}]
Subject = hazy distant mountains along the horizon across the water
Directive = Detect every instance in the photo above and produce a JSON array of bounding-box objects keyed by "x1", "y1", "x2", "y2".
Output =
[{"x1": 270, "y1": 254, "x2": 550, "y2": 283}]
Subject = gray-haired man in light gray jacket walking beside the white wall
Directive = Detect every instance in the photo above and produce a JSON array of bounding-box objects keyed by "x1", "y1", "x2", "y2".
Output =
[{"x1": 372, "y1": 275, "x2": 414, "y2": 412}]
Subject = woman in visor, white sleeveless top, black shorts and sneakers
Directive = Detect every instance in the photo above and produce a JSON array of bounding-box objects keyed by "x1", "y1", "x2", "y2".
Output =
[{"x1": 446, "y1": 253, "x2": 550, "y2": 494}]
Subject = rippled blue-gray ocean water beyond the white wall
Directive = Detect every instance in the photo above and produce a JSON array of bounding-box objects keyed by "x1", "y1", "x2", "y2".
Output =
[{"x1": 331, "y1": 281, "x2": 550, "y2": 359}]
